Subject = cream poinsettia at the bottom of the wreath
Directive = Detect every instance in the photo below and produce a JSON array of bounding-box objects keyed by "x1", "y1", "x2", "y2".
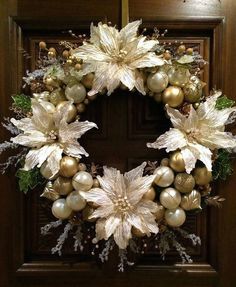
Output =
[{"x1": 81, "y1": 162, "x2": 159, "y2": 249}]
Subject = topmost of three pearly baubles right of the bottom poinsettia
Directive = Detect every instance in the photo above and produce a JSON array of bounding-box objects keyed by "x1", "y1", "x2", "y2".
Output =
[{"x1": 153, "y1": 166, "x2": 175, "y2": 187}]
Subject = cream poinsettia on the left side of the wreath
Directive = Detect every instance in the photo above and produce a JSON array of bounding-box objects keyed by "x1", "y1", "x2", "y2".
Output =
[{"x1": 11, "y1": 99, "x2": 97, "y2": 175}]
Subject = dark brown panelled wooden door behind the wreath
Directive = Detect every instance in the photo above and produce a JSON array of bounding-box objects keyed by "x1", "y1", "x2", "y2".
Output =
[{"x1": 0, "y1": 0, "x2": 236, "y2": 287}]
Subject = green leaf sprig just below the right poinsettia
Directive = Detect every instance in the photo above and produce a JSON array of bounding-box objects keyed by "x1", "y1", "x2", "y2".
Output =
[{"x1": 212, "y1": 149, "x2": 233, "y2": 180}]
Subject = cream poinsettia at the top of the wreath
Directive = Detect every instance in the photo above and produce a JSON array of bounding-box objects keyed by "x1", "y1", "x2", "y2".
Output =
[{"x1": 73, "y1": 20, "x2": 164, "y2": 95}]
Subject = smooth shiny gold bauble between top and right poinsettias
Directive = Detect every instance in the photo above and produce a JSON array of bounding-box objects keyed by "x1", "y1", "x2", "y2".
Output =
[{"x1": 162, "y1": 86, "x2": 184, "y2": 108}]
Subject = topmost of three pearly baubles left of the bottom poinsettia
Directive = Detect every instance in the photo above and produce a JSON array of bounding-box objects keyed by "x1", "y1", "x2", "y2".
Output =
[{"x1": 72, "y1": 171, "x2": 93, "y2": 191}]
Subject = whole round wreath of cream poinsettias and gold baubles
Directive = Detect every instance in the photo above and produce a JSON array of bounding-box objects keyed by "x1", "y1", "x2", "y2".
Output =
[{"x1": 0, "y1": 21, "x2": 236, "y2": 271}]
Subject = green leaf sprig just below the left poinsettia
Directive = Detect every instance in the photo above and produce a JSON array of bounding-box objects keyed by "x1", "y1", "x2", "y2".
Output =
[{"x1": 16, "y1": 168, "x2": 44, "y2": 194}]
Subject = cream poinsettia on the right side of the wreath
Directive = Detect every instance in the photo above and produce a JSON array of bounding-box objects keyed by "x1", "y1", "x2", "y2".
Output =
[{"x1": 147, "y1": 92, "x2": 236, "y2": 173}]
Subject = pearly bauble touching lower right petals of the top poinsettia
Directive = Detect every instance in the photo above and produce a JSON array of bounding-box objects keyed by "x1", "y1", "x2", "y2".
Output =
[{"x1": 147, "y1": 71, "x2": 168, "y2": 93}]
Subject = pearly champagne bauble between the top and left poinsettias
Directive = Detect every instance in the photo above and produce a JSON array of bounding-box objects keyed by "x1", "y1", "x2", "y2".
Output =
[{"x1": 65, "y1": 83, "x2": 87, "y2": 104}]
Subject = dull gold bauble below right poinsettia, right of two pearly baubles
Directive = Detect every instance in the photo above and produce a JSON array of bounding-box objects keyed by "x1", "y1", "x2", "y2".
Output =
[{"x1": 174, "y1": 172, "x2": 195, "y2": 193}]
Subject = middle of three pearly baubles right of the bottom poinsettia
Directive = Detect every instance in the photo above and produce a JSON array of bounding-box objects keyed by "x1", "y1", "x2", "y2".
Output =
[{"x1": 160, "y1": 187, "x2": 181, "y2": 209}]
